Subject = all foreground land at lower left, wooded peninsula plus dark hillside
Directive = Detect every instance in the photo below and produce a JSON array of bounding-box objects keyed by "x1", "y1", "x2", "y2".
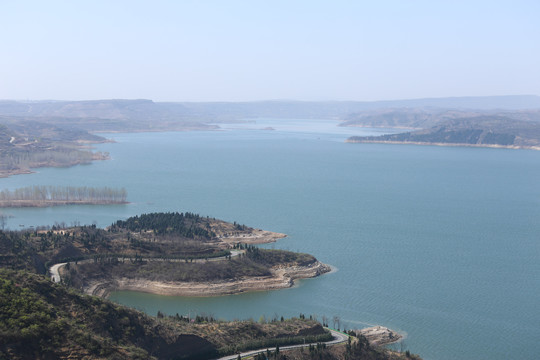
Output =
[{"x1": 0, "y1": 212, "x2": 417, "y2": 360}]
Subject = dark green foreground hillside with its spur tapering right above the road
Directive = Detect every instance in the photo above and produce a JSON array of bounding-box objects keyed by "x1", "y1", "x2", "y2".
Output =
[{"x1": 0, "y1": 269, "x2": 342, "y2": 359}]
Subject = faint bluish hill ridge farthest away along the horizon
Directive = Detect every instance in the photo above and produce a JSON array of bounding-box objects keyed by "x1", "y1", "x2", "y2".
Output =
[{"x1": 0, "y1": 95, "x2": 540, "y2": 130}]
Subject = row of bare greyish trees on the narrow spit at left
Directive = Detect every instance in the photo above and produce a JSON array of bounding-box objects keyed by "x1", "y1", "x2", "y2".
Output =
[{"x1": 0, "y1": 186, "x2": 127, "y2": 204}]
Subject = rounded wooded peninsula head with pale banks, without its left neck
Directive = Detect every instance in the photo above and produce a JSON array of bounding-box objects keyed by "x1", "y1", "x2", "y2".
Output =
[{"x1": 65, "y1": 213, "x2": 330, "y2": 296}]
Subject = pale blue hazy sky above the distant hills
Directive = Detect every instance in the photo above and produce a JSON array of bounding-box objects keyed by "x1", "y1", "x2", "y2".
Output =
[{"x1": 0, "y1": 0, "x2": 540, "y2": 101}]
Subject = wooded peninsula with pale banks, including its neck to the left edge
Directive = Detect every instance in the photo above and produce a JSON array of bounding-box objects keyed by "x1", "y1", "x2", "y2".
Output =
[{"x1": 2, "y1": 212, "x2": 330, "y2": 296}]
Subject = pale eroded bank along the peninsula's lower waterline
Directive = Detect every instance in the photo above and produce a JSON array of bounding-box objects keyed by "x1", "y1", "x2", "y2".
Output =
[{"x1": 84, "y1": 261, "x2": 331, "y2": 297}]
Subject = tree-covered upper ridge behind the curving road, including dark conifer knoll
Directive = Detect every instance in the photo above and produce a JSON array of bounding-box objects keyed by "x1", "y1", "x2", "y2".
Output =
[{"x1": 0, "y1": 212, "x2": 260, "y2": 273}]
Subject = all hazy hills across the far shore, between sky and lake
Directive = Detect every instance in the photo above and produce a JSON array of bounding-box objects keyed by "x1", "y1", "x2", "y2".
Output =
[{"x1": 0, "y1": 95, "x2": 540, "y2": 152}]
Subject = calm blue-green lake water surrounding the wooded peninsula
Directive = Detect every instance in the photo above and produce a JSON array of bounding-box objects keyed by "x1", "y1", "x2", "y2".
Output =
[{"x1": 0, "y1": 120, "x2": 540, "y2": 360}]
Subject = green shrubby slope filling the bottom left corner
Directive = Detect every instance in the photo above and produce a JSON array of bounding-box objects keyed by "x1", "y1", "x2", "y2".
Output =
[{"x1": 0, "y1": 269, "x2": 217, "y2": 359}]
